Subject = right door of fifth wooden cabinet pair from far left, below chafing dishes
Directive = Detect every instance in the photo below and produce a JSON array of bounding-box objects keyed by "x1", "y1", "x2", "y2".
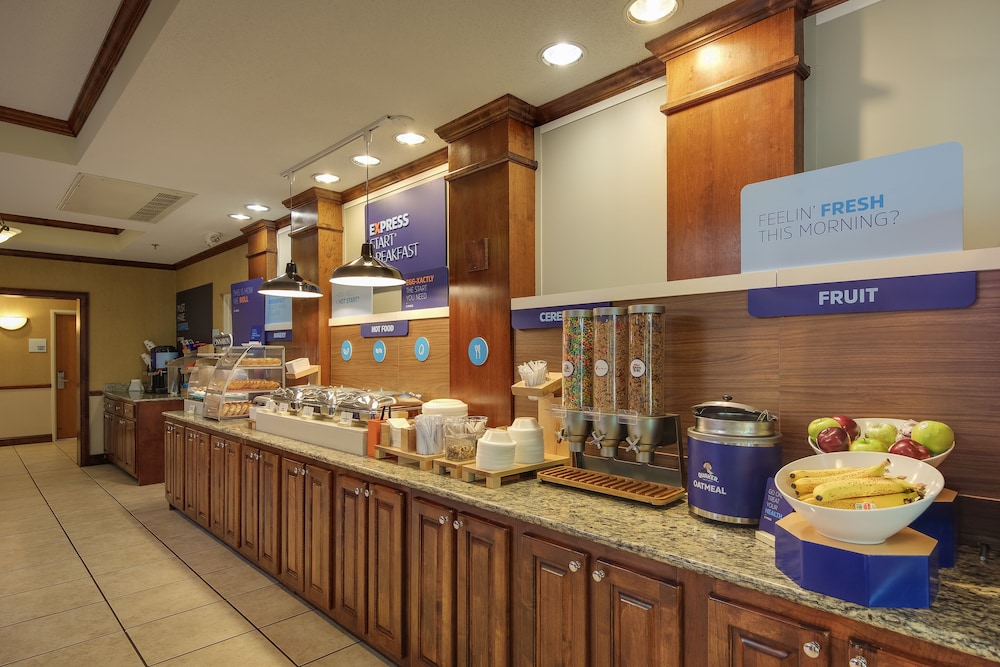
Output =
[{"x1": 304, "y1": 465, "x2": 333, "y2": 612}]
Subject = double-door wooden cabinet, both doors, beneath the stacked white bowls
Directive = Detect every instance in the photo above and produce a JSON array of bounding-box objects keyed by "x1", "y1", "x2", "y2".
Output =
[{"x1": 409, "y1": 498, "x2": 511, "y2": 666}]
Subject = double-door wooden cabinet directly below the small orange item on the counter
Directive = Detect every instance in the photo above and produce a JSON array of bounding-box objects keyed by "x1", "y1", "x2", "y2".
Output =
[{"x1": 332, "y1": 473, "x2": 406, "y2": 661}]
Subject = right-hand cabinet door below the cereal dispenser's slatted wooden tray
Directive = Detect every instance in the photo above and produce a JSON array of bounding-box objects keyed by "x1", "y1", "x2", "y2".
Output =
[{"x1": 590, "y1": 560, "x2": 682, "y2": 667}]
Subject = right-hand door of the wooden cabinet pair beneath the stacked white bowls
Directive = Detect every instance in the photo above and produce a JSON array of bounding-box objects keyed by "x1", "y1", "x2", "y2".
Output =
[{"x1": 456, "y1": 513, "x2": 512, "y2": 666}]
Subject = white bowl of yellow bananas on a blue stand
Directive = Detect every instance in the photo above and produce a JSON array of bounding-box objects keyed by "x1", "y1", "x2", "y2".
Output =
[{"x1": 774, "y1": 451, "x2": 944, "y2": 544}]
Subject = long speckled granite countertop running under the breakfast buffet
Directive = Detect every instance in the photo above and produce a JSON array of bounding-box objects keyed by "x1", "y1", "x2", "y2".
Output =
[{"x1": 166, "y1": 412, "x2": 1000, "y2": 661}]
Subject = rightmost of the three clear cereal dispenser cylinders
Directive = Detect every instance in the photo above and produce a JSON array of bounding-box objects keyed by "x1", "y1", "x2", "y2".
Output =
[{"x1": 628, "y1": 304, "x2": 666, "y2": 416}]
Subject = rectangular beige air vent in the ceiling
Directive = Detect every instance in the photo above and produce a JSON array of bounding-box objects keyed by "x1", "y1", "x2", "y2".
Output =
[{"x1": 59, "y1": 174, "x2": 195, "y2": 222}]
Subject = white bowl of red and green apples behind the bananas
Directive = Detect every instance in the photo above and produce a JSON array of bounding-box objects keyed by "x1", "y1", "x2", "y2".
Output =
[{"x1": 809, "y1": 415, "x2": 955, "y2": 468}]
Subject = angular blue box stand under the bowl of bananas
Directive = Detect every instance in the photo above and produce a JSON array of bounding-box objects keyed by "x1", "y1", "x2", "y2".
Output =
[{"x1": 774, "y1": 512, "x2": 938, "y2": 608}]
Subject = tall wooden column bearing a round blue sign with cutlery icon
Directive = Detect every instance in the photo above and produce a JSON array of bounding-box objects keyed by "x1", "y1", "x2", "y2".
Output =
[{"x1": 435, "y1": 95, "x2": 537, "y2": 425}]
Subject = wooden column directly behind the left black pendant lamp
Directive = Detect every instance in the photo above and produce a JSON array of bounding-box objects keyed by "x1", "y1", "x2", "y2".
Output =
[{"x1": 282, "y1": 188, "x2": 344, "y2": 378}]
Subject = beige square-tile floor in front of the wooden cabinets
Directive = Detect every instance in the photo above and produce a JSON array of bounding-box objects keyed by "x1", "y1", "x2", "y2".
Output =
[{"x1": 0, "y1": 441, "x2": 389, "y2": 667}]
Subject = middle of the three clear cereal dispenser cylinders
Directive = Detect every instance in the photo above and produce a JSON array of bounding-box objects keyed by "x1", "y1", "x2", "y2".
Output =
[{"x1": 593, "y1": 308, "x2": 629, "y2": 413}]
